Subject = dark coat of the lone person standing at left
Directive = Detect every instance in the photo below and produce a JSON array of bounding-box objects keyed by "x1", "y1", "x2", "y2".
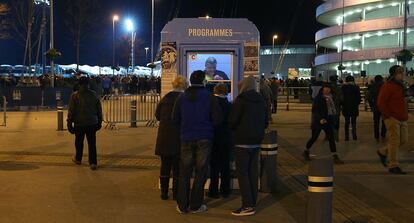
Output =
[{"x1": 67, "y1": 86, "x2": 102, "y2": 127}]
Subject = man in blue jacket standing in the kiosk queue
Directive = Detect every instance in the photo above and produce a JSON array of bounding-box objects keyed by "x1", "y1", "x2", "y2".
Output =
[{"x1": 173, "y1": 70, "x2": 222, "y2": 214}]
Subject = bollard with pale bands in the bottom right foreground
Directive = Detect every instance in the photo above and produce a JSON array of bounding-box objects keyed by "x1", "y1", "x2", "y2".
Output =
[{"x1": 307, "y1": 159, "x2": 333, "y2": 223}]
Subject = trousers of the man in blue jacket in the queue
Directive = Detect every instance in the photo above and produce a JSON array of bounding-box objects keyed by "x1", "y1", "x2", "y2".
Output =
[{"x1": 177, "y1": 140, "x2": 212, "y2": 211}]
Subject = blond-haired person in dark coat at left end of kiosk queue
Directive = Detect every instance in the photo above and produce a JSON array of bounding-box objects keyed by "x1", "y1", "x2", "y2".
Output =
[{"x1": 155, "y1": 76, "x2": 188, "y2": 200}]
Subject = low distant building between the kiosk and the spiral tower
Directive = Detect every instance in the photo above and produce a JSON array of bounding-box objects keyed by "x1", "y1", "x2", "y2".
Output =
[{"x1": 260, "y1": 45, "x2": 315, "y2": 79}]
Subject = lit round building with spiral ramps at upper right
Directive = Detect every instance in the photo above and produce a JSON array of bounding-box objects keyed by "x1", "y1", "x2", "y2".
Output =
[{"x1": 315, "y1": 0, "x2": 414, "y2": 76}]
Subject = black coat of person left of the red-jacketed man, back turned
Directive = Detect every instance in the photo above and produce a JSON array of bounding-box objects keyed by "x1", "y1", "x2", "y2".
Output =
[{"x1": 342, "y1": 84, "x2": 361, "y2": 117}]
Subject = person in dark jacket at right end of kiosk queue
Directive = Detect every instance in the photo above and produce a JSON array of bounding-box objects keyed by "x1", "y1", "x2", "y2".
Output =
[{"x1": 229, "y1": 76, "x2": 268, "y2": 216}]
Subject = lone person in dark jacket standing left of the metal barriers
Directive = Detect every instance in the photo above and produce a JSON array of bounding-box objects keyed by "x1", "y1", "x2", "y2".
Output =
[{"x1": 67, "y1": 77, "x2": 102, "y2": 170}]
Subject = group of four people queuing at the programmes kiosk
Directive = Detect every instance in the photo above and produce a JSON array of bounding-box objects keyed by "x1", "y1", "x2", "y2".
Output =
[{"x1": 156, "y1": 71, "x2": 268, "y2": 216}]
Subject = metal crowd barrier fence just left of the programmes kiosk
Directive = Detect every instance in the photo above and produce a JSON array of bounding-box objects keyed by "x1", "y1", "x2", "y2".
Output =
[{"x1": 102, "y1": 94, "x2": 160, "y2": 129}]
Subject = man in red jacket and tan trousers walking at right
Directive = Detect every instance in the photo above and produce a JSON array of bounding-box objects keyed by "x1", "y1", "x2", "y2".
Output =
[{"x1": 377, "y1": 65, "x2": 408, "y2": 174}]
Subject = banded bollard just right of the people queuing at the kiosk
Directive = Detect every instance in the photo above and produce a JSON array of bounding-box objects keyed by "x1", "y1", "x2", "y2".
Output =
[{"x1": 260, "y1": 131, "x2": 278, "y2": 193}]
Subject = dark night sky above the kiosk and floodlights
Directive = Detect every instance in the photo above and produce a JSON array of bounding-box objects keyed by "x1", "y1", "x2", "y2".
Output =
[{"x1": 0, "y1": 0, "x2": 322, "y2": 66}]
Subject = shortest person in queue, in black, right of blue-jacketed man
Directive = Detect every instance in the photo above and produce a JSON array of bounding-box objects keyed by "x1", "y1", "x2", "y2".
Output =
[{"x1": 207, "y1": 84, "x2": 232, "y2": 198}]
